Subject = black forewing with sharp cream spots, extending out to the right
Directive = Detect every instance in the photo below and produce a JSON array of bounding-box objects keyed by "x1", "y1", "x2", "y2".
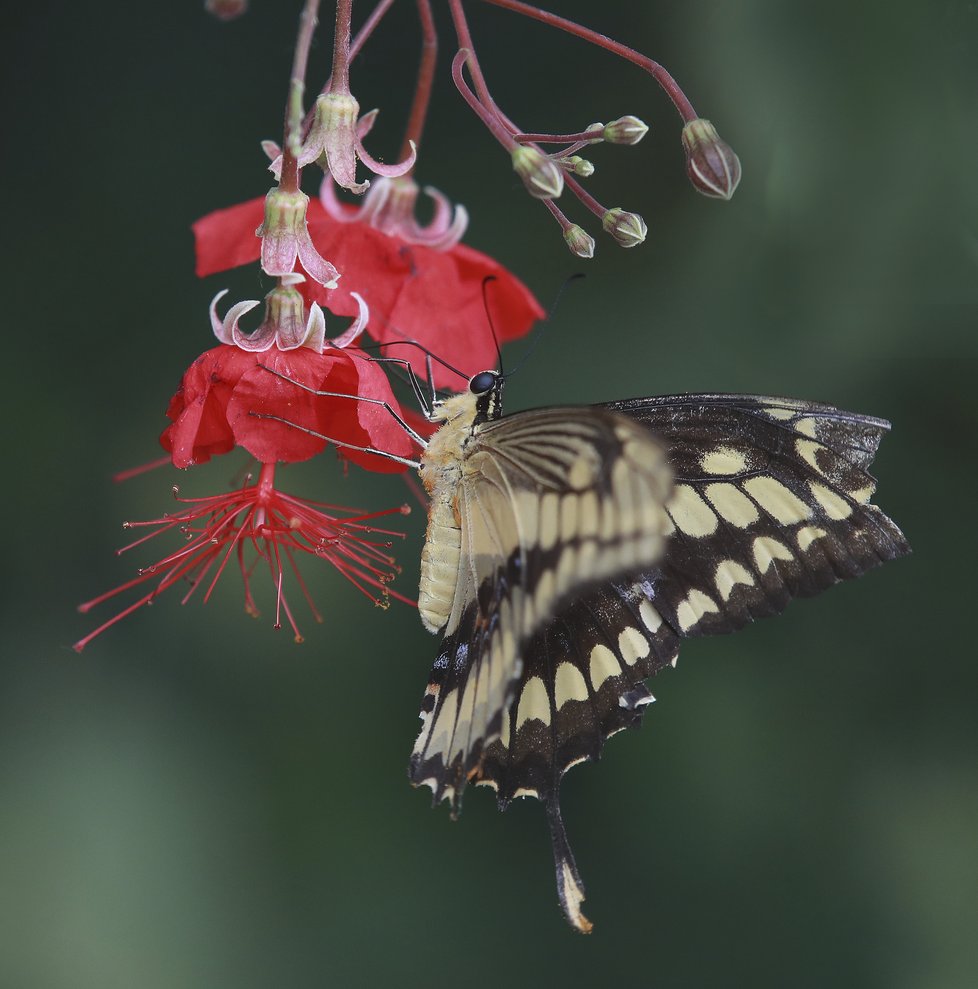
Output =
[{"x1": 609, "y1": 395, "x2": 908, "y2": 635}]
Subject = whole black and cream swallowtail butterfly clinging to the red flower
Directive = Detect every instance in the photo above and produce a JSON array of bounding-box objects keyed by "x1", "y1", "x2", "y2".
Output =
[{"x1": 409, "y1": 371, "x2": 909, "y2": 931}]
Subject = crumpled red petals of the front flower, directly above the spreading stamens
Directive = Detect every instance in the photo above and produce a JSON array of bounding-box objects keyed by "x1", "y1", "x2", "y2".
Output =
[{"x1": 160, "y1": 344, "x2": 417, "y2": 471}]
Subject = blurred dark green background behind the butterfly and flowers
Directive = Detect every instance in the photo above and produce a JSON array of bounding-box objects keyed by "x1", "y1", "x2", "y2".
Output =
[{"x1": 0, "y1": 0, "x2": 978, "y2": 989}]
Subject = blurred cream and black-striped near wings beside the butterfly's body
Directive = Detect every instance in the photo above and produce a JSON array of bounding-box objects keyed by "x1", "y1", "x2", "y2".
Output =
[{"x1": 411, "y1": 408, "x2": 669, "y2": 808}]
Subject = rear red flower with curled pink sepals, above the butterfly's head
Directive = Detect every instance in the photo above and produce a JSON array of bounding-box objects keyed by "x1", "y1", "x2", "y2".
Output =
[{"x1": 194, "y1": 179, "x2": 543, "y2": 389}]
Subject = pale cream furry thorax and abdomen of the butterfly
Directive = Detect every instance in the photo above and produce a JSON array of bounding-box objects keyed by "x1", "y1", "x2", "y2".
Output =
[{"x1": 418, "y1": 392, "x2": 477, "y2": 632}]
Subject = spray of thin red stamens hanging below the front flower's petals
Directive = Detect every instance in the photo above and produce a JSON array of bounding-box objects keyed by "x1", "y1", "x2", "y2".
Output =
[{"x1": 74, "y1": 464, "x2": 411, "y2": 652}]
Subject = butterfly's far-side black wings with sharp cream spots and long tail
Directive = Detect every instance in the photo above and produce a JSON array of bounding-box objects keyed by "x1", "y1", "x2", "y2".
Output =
[{"x1": 408, "y1": 395, "x2": 909, "y2": 931}]
